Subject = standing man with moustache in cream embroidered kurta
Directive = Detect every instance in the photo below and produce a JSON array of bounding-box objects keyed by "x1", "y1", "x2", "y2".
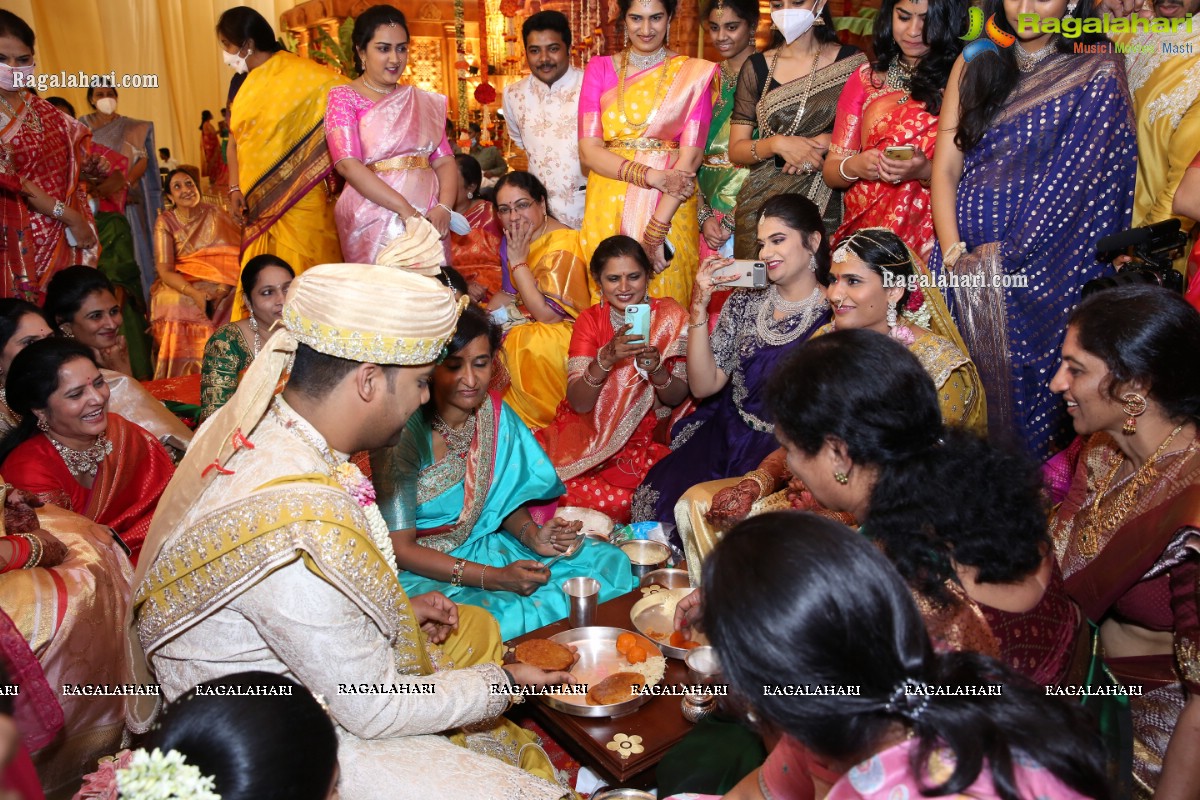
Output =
[{"x1": 504, "y1": 11, "x2": 587, "y2": 230}]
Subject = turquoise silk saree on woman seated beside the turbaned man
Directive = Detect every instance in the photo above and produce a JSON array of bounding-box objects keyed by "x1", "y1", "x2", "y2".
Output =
[{"x1": 371, "y1": 393, "x2": 635, "y2": 639}]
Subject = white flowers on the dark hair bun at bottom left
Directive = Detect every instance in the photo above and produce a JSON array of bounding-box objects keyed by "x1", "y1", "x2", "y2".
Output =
[{"x1": 76, "y1": 747, "x2": 221, "y2": 800}]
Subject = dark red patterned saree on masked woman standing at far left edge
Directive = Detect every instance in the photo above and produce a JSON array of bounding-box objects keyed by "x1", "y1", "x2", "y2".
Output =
[{"x1": 0, "y1": 92, "x2": 100, "y2": 299}]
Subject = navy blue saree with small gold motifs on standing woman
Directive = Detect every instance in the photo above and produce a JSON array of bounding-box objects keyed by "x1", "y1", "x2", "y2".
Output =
[{"x1": 930, "y1": 54, "x2": 1136, "y2": 459}]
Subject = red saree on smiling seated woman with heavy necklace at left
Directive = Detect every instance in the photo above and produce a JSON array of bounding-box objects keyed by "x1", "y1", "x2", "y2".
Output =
[{"x1": 2, "y1": 414, "x2": 175, "y2": 564}]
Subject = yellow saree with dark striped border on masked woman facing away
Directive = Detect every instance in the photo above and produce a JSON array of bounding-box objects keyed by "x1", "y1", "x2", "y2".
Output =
[{"x1": 229, "y1": 52, "x2": 348, "y2": 319}]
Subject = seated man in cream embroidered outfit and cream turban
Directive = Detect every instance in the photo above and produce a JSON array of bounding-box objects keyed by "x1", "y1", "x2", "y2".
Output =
[{"x1": 130, "y1": 265, "x2": 568, "y2": 800}]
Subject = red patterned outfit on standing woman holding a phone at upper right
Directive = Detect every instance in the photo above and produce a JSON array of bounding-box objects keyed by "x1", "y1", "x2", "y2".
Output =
[{"x1": 829, "y1": 64, "x2": 937, "y2": 261}]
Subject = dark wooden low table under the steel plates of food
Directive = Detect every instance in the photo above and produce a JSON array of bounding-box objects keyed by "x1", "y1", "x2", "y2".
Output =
[{"x1": 509, "y1": 589, "x2": 692, "y2": 788}]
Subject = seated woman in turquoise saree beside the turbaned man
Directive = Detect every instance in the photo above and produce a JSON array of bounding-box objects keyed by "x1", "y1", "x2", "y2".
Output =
[{"x1": 371, "y1": 306, "x2": 635, "y2": 639}]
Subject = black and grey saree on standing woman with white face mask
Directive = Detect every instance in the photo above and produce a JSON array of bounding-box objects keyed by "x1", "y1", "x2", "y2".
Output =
[{"x1": 731, "y1": 47, "x2": 866, "y2": 258}]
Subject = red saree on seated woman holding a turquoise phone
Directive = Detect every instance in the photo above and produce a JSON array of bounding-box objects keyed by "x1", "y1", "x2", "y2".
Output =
[{"x1": 535, "y1": 297, "x2": 688, "y2": 523}]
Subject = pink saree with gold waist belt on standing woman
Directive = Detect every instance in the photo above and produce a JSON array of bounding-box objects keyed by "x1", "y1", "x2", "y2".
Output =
[{"x1": 325, "y1": 86, "x2": 454, "y2": 264}]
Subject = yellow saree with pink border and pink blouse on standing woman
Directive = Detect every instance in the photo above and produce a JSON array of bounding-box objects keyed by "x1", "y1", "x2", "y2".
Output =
[{"x1": 580, "y1": 55, "x2": 716, "y2": 306}]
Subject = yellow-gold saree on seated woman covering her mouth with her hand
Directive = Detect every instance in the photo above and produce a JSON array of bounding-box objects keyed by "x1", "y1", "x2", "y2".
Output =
[{"x1": 500, "y1": 228, "x2": 590, "y2": 431}]
